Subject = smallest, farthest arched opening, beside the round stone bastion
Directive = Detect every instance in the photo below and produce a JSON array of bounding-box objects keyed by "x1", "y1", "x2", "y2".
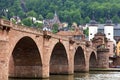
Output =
[{"x1": 89, "y1": 52, "x2": 97, "y2": 69}]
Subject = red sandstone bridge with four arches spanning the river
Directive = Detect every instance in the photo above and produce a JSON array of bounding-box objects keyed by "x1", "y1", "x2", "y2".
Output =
[{"x1": 0, "y1": 19, "x2": 108, "y2": 80}]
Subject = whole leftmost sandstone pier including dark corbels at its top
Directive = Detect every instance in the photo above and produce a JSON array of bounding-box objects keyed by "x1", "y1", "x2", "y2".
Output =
[{"x1": 0, "y1": 25, "x2": 10, "y2": 80}]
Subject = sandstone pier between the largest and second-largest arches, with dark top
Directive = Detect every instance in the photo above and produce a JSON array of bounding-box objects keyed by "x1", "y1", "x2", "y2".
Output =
[{"x1": 42, "y1": 31, "x2": 51, "y2": 78}]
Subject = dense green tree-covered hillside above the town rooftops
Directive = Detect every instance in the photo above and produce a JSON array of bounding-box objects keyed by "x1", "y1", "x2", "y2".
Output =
[{"x1": 0, "y1": 0, "x2": 120, "y2": 24}]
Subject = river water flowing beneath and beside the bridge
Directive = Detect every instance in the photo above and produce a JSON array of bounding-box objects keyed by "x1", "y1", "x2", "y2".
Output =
[{"x1": 9, "y1": 71, "x2": 120, "y2": 80}]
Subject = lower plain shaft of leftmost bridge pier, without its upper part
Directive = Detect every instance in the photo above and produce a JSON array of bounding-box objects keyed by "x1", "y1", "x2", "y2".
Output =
[{"x1": 0, "y1": 40, "x2": 9, "y2": 80}]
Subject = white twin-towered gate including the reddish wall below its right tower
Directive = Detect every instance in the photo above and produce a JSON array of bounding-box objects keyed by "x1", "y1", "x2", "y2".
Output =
[{"x1": 88, "y1": 19, "x2": 116, "y2": 57}]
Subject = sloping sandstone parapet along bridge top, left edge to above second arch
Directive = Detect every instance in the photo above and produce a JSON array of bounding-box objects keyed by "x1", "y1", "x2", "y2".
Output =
[{"x1": 0, "y1": 19, "x2": 69, "y2": 41}]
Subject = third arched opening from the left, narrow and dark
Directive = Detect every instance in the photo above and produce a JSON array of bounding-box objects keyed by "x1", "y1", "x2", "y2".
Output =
[{"x1": 74, "y1": 47, "x2": 85, "y2": 72}]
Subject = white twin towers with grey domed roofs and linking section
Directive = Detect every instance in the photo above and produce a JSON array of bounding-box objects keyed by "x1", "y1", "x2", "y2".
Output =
[{"x1": 88, "y1": 20, "x2": 116, "y2": 44}]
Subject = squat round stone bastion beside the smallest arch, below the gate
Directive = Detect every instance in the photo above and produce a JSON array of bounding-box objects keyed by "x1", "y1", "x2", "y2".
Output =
[{"x1": 97, "y1": 49, "x2": 109, "y2": 68}]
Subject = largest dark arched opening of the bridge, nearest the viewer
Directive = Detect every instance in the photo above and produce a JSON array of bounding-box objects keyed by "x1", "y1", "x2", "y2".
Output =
[{"x1": 9, "y1": 37, "x2": 42, "y2": 78}]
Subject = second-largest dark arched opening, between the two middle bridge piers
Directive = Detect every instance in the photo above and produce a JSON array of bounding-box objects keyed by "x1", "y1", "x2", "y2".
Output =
[{"x1": 50, "y1": 43, "x2": 68, "y2": 74}]
